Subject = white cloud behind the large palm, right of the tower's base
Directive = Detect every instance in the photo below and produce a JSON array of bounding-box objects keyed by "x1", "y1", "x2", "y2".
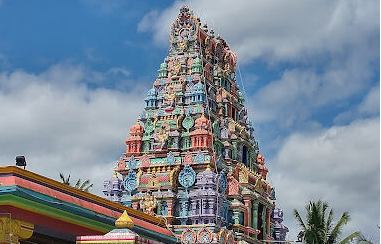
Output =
[{"x1": 267, "y1": 118, "x2": 380, "y2": 239}]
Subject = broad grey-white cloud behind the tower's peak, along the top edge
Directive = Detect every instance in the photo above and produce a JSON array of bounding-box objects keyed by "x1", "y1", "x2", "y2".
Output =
[{"x1": 138, "y1": 0, "x2": 379, "y2": 62}]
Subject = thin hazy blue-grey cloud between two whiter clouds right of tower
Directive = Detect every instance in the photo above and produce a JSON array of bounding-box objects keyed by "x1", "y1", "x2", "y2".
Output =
[{"x1": 247, "y1": 48, "x2": 379, "y2": 128}]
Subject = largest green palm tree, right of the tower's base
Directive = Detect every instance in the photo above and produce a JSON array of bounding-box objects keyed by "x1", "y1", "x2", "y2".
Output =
[{"x1": 294, "y1": 200, "x2": 360, "y2": 244}]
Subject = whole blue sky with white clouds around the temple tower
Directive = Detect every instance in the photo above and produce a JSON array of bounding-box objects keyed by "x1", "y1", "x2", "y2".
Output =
[{"x1": 0, "y1": 0, "x2": 380, "y2": 243}]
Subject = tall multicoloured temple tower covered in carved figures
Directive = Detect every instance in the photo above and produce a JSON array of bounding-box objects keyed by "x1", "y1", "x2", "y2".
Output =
[{"x1": 104, "y1": 6, "x2": 286, "y2": 243}]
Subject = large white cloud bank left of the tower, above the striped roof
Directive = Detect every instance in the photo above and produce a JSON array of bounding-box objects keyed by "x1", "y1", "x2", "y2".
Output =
[{"x1": 0, "y1": 64, "x2": 146, "y2": 195}]
